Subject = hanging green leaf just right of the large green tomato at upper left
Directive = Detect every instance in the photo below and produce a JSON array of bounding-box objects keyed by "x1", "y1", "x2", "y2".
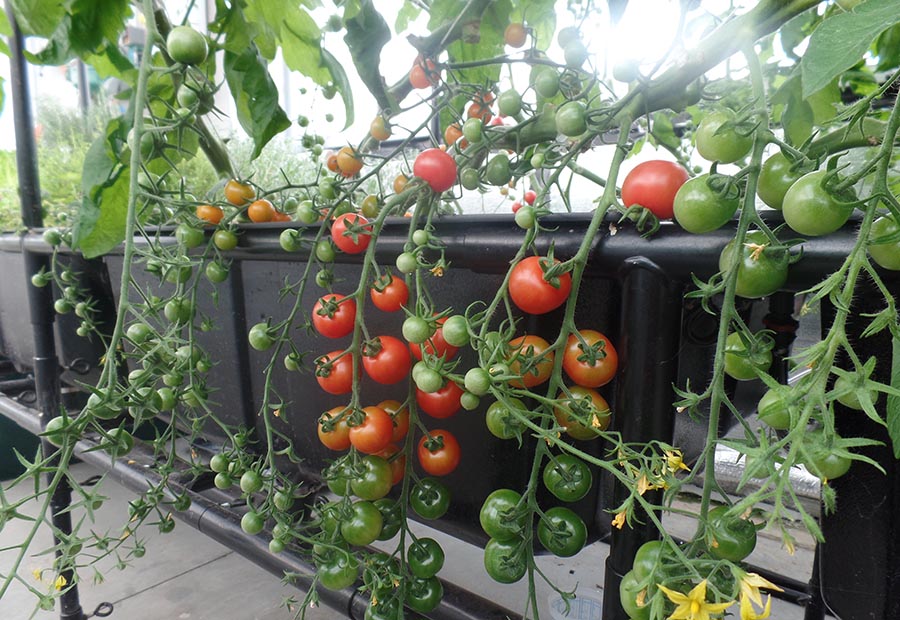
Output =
[{"x1": 225, "y1": 44, "x2": 291, "y2": 159}]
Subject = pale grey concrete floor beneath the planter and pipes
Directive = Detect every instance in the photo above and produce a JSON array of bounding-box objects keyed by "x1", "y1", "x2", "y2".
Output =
[{"x1": 0, "y1": 464, "x2": 824, "y2": 620}]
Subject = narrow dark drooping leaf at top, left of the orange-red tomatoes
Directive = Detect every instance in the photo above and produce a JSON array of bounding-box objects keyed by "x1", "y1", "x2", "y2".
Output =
[{"x1": 342, "y1": 0, "x2": 393, "y2": 114}]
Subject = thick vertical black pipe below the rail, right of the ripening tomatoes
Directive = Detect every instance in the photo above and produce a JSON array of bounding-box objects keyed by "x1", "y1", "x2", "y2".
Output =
[{"x1": 603, "y1": 257, "x2": 683, "y2": 620}]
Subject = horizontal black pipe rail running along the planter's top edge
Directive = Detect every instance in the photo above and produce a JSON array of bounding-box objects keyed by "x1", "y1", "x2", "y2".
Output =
[{"x1": 0, "y1": 212, "x2": 872, "y2": 291}]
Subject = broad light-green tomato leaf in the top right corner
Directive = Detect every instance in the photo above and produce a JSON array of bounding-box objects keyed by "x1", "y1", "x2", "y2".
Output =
[{"x1": 800, "y1": 0, "x2": 900, "y2": 98}]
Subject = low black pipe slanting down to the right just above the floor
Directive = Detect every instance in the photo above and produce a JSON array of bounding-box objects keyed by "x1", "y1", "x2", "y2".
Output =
[{"x1": 0, "y1": 394, "x2": 520, "y2": 620}]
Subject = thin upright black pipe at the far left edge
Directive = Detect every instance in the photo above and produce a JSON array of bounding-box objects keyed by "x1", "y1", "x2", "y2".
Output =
[{"x1": 6, "y1": 6, "x2": 85, "y2": 620}]
